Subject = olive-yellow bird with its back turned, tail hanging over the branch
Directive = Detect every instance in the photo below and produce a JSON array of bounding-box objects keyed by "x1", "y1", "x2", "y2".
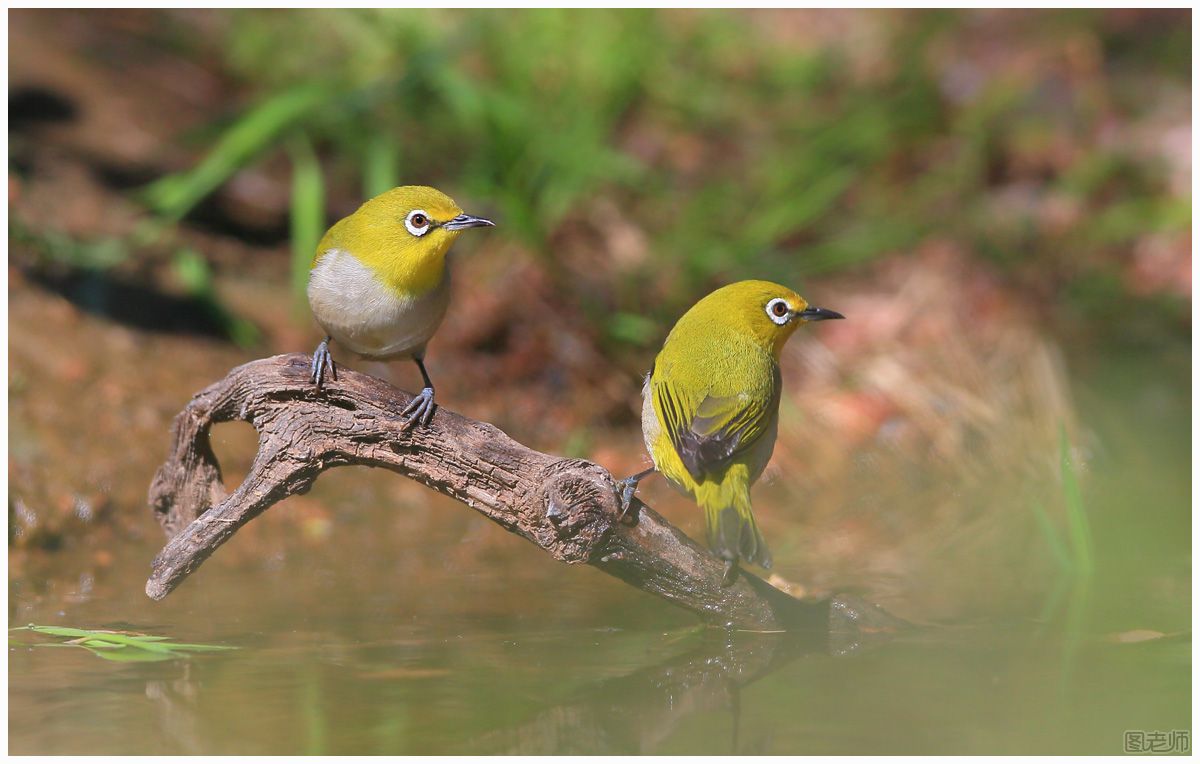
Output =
[{"x1": 619, "y1": 281, "x2": 845, "y2": 585}]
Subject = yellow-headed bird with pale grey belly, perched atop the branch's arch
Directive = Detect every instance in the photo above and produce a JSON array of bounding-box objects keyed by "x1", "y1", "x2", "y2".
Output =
[{"x1": 308, "y1": 186, "x2": 494, "y2": 425}]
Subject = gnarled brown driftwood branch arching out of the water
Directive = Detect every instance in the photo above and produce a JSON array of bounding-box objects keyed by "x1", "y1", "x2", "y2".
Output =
[{"x1": 146, "y1": 355, "x2": 901, "y2": 636}]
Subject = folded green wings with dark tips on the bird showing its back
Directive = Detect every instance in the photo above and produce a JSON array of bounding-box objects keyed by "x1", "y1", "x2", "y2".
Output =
[{"x1": 650, "y1": 367, "x2": 780, "y2": 481}]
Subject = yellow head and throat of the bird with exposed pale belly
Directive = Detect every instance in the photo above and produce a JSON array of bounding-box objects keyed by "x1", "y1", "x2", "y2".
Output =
[{"x1": 313, "y1": 186, "x2": 494, "y2": 294}]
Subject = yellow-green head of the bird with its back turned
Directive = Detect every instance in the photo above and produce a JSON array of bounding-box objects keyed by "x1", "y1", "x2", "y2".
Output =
[{"x1": 689, "y1": 281, "x2": 845, "y2": 359}]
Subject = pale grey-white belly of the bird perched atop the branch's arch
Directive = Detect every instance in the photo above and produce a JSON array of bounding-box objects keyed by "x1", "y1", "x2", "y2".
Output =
[{"x1": 308, "y1": 249, "x2": 450, "y2": 357}]
